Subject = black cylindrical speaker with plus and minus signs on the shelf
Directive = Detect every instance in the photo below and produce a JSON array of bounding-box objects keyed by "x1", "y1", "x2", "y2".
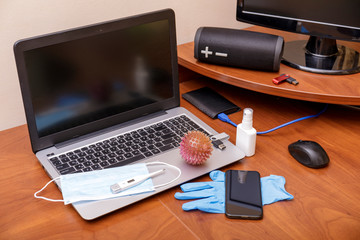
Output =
[{"x1": 194, "y1": 27, "x2": 284, "y2": 72}]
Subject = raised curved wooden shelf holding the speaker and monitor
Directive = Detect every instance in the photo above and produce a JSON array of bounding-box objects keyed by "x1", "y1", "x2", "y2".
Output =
[{"x1": 178, "y1": 27, "x2": 360, "y2": 105}]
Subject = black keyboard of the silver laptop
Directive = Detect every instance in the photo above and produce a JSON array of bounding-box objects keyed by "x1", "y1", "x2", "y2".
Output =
[{"x1": 49, "y1": 115, "x2": 209, "y2": 175}]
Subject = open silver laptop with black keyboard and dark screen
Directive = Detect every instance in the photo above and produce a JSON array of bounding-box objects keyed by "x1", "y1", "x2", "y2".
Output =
[{"x1": 14, "y1": 9, "x2": 244, "y2": 220}]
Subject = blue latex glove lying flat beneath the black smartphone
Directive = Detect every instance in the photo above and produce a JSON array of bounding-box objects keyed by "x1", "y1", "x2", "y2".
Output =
[{"x1": 175, "y1": 170, "x2": 294, "y2": 213}]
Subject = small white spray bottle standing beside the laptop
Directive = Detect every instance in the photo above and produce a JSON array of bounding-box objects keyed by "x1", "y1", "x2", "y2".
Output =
[{"x1": 236, "y1": 108, "x2": 256, "y2": 157}]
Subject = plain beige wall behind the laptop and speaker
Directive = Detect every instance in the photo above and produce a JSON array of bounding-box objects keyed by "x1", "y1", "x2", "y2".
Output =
[{"x1": 0, "y1": 0, "x2": 248, "y2": 130}]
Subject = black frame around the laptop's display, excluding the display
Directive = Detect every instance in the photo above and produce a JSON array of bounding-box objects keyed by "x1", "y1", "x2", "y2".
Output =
[{"x1": 14, "y1": 9, "x2": 180, "y2": 153}]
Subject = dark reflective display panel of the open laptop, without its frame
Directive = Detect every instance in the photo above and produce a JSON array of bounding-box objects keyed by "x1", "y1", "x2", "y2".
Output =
[{"x1": 24, "y1": 20, "x2": 173, "y2": 137}]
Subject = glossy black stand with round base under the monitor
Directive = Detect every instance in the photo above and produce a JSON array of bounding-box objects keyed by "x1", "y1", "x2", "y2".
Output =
[{"x1": 282, "y1": 36, "x2": 360, "y2": 75}]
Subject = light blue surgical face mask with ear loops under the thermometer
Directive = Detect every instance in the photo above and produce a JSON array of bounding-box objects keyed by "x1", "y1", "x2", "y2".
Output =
[{"x1": 34, "y1": 162, "x2": 181, "y2": 205}]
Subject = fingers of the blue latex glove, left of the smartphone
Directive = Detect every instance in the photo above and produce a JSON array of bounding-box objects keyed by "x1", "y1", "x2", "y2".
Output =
[{"x1": 175, "y1": 170, "x2": 225, "y2": 213}]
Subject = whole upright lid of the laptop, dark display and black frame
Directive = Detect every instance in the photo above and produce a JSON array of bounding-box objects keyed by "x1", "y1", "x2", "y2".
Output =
[{"x1": 14, "y1": 10, "x2": 179, "y2": 152}]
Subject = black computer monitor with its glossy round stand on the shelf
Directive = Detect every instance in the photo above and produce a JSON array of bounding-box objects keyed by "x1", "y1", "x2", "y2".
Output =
[{"x1": 236, "y1": 0, "x2": 360, "y2": 74}]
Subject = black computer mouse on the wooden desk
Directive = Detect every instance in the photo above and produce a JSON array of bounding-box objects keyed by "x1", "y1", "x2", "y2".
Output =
[{"x1": 288, "y1": 140, "x2": 330, "y2": 168}]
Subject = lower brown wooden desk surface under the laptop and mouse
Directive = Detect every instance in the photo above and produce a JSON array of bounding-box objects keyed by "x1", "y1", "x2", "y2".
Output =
[{"x1": 0, "y1": 79, "x2": 360, "y2": 239}]
